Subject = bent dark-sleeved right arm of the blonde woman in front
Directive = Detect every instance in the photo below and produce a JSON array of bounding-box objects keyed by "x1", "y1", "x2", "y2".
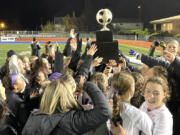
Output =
[{"x1": 71, "y1": 82, "x2": 112, "y2": 134}]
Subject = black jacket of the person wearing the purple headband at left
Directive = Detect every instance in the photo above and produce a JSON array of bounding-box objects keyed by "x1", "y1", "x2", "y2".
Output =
[{"x1": 0, "y1": 90, "x2": 30, "y2": 135}]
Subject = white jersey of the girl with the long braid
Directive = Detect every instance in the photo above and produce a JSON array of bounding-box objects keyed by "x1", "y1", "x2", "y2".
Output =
[{"x1": 120, "y1": 102, "x2": 153, "y2": 135}]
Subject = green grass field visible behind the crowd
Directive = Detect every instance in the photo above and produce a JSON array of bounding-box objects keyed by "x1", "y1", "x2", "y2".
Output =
[{"x1": 0, "y1": 44, "x2": 160, "y2": 66}]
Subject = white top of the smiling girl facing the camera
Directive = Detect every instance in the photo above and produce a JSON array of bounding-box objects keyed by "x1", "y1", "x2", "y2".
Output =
[{"x1": 140, "y1": 102, "x2": 173, "y2": 135}]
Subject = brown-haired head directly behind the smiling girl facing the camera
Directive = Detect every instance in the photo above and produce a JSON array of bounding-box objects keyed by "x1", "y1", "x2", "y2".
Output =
[{"x1": 143, "y1": 66, "x2": 168, "y2": 81}]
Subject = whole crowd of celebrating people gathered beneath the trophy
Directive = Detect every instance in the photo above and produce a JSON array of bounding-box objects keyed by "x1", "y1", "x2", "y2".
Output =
[{"x1": 0, "y1": 30, "x2": 180, "y2": 135}]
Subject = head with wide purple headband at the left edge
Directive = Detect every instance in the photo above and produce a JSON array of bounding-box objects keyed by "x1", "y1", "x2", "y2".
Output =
[{"x1": 2, "y1": 73, "x2": 25, "y2": 93}]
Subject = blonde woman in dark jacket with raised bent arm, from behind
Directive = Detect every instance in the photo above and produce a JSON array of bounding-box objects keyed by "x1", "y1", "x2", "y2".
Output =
[{"x1": 22, "y1": 75, "x2": 111, "y2": 135}]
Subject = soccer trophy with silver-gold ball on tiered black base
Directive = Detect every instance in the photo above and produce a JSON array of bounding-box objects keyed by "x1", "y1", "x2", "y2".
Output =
[{"x1": 95, "y1": 9, "x2": 119, "y2": 63}]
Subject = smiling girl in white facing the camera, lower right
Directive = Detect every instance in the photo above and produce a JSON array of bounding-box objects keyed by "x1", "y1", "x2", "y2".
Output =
[{"x1": 140, "y1": 76, "x2": 173, "y2": 135}]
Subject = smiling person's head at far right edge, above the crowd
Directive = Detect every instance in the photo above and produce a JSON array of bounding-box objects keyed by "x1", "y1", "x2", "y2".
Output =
[{"x1": 165, "y1": 40, "x2": 179, "y2": 55}]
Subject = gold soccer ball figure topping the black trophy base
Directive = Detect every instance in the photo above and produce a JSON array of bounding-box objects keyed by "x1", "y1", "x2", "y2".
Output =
[{"x1": 96, "y1": 9, "x2": 112, "y2": 31}]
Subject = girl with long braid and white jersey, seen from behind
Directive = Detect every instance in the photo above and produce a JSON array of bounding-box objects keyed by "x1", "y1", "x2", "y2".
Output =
[{"x1": 111, "y1": 71, "x2": 153, "y2": 135}]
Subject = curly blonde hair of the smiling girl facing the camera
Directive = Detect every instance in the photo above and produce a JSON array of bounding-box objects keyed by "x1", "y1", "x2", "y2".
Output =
[{"x1": 144, "y1": 76, "x2": 171, "y2": 103}]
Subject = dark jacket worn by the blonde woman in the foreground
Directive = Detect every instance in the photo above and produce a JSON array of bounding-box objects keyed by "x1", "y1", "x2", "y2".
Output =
[{"x1": 22, "y1": 82, "x2": 112, "y2": 135}]
